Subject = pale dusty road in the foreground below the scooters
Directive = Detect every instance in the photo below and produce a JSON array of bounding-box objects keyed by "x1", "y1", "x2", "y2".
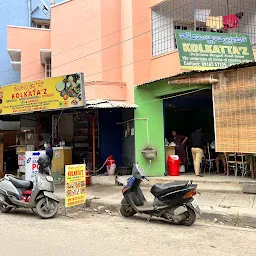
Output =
[{"x1": 0, "y1": 208, "x2": 256, "y2": 256}]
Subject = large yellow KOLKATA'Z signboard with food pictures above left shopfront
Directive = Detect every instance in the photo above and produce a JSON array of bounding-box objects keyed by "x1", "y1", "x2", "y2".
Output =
[{"x1": 0, "y1": 73, "x2": 85, "y2": 115}]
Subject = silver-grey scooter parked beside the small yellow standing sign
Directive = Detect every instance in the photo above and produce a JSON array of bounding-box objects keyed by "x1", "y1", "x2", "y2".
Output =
[{"x1": 0, "y1": 155, "x2": 59, "y2": 219}]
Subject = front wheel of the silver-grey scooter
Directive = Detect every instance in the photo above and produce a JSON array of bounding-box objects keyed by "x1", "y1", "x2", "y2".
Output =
[{"x1": 36, "y1": 197, "x2": 59, "y2": 219}]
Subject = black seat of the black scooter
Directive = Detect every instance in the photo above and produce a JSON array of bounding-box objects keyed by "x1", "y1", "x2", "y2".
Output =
[{"x1": 150, "y1": 181, "x2": 189, "y2": 197}]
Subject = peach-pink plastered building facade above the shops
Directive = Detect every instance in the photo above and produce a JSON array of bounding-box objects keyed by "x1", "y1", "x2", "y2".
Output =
[{"x1": 8, "y1": 0, "x2": 192, "y2": 103}]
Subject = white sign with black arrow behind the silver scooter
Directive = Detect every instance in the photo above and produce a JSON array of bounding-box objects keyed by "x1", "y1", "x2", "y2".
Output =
[{"x1": 25, "y1": 151, "x2": 45, "y2": 182}]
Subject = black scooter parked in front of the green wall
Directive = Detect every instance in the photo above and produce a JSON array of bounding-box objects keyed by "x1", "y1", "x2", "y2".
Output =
[{"x1": 120, "y1": 164, "x2": 201, "y2": 226}]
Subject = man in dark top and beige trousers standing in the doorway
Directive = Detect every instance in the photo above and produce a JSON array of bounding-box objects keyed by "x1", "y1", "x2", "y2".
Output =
[{"x1": 190, "y1": 128, "x2": 206, "y2": 177}]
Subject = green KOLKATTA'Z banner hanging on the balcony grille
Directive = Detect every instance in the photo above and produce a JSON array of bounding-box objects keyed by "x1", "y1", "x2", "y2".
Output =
[{"x1": 175, "y1": 30, "x2": 254, "y2": 70}]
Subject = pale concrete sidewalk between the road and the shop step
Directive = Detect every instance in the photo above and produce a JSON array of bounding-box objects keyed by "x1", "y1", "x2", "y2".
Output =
[{"x1": 55, "y1": 185, "x2": 256, "y2": 228}]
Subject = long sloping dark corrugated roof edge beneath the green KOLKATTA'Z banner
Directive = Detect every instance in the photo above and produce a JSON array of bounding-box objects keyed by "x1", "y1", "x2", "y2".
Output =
[{"x1": 136, "y1": 61, "x2": 256, "y2": 87}]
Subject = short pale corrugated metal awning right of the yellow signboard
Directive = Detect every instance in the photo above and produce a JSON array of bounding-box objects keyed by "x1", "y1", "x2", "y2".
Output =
[{"x1": 86, "y1": 99, "x2": 138, "y2": 109}]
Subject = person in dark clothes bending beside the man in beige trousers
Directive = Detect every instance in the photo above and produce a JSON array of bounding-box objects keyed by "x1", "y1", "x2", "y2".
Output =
[{"x1": 171, "y1": 131, "x2": 188, "y2": 166}]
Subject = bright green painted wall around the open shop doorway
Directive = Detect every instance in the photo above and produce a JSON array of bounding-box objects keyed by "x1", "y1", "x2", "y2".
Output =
[{"x1": 134, "y1": 79, "x2": 209, "y2": 176}]
